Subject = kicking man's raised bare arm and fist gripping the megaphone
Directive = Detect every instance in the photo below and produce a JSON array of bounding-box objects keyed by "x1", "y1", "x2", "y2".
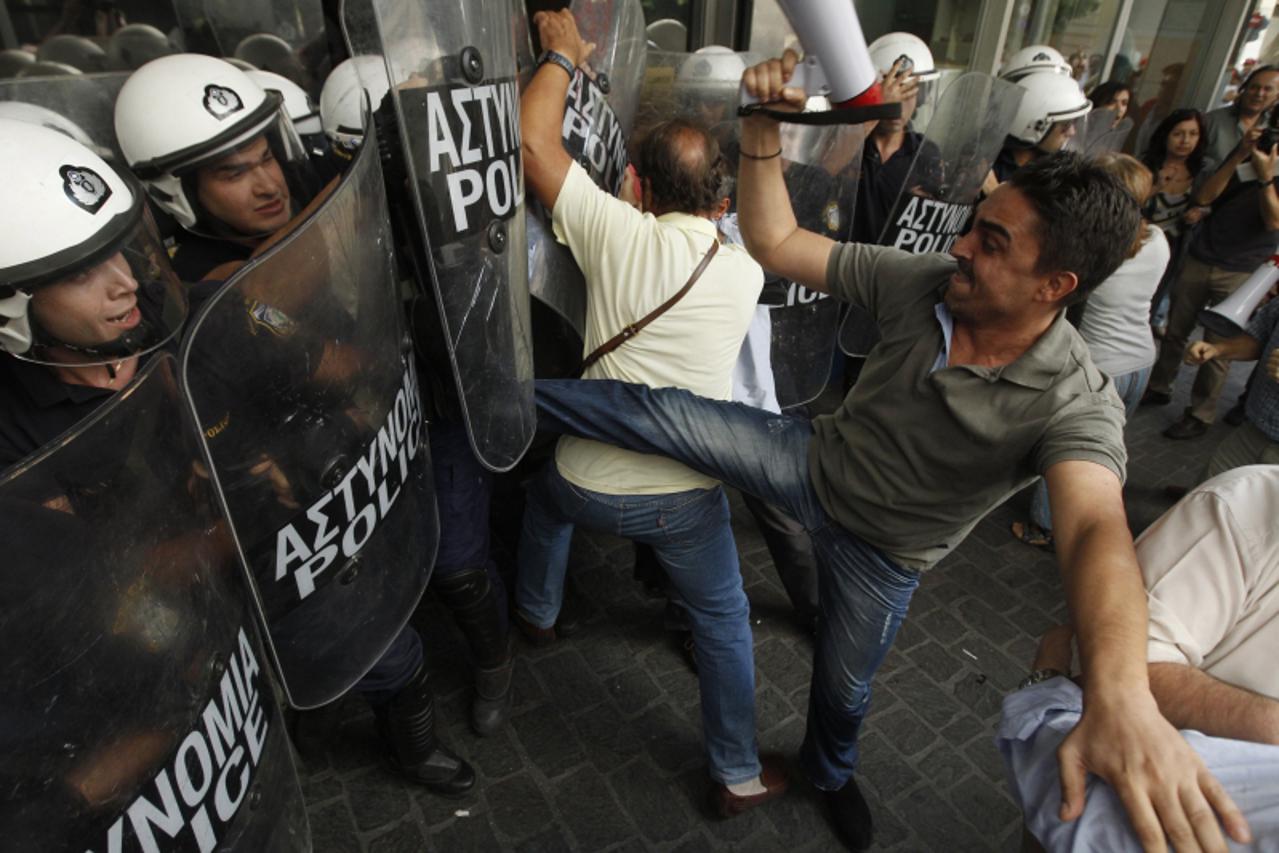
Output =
[{"x1": 737, "y1": 50, "x2": 835, "y2": 293}]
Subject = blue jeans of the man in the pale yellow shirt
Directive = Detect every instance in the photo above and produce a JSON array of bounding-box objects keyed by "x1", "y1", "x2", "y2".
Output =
[{"x1": 515, "y1": 460, "x2": 760, "y2": 784}]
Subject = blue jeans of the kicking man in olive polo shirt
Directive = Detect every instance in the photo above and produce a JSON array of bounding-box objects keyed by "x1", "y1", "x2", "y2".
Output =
[{"x1": 537, "y1": 380, "x2": 920, "y2": 790}]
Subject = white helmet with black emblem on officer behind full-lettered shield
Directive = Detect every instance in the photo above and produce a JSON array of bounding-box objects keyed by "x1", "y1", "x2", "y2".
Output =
[{"x1": 115, "y1": 54, "x2": 306, "y2": 229}]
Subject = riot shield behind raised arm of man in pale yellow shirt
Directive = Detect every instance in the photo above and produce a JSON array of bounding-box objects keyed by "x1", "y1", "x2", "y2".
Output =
[{"x1": 527, "y1": 0, "x2": 647, "y2": 342}]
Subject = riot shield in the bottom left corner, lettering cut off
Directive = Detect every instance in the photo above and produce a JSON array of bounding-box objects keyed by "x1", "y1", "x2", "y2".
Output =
[{"x1": 0, "y1": 354, "x2": 311, "y2": 852}]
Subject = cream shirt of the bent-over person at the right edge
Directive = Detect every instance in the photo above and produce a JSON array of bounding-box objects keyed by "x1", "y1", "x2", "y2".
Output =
[{"x1": 1137, "y1": 466, "x2": 1279, "y2": 700}]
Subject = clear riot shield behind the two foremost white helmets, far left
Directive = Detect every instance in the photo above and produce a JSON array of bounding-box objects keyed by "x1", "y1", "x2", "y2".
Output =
[{"x1": 0, "y1": 72, "x2": 132, "y2": 162}]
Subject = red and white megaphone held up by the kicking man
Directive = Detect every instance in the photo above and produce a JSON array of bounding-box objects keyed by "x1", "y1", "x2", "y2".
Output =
[{"x1": 742, "y1": 0, "x2": 888, "y2": 118}]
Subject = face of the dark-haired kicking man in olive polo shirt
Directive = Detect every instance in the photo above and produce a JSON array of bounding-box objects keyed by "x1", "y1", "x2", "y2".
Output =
[{"x1": 944, "y1": 184, "x2": 1064, "y2": 326}]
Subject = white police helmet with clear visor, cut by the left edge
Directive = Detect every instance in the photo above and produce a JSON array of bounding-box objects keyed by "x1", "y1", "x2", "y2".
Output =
[{"x1": 0, "y1": 119, "x2": 185, "y2": 363}]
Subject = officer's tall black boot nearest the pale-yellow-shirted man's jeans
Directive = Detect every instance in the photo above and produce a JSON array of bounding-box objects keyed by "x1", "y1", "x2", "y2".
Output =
[{"x1": 432, "y1": 569, "x2": 515, "y2": 735}]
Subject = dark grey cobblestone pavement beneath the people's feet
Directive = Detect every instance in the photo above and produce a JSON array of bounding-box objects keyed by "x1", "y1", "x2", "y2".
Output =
[{"x1": 301, "y1": 366, "x2": 1250, "y2": 853}]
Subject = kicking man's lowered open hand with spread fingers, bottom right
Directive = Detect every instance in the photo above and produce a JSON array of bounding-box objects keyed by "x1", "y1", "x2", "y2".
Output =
[{"x1": 1056, "y1": 691, "x2": 1252, "y2": 853}]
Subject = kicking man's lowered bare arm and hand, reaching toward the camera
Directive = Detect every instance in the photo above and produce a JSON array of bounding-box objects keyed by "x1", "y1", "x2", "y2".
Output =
[{"x1": 1046, "y1": 460, "x2": 1250, "y2": 853}]
